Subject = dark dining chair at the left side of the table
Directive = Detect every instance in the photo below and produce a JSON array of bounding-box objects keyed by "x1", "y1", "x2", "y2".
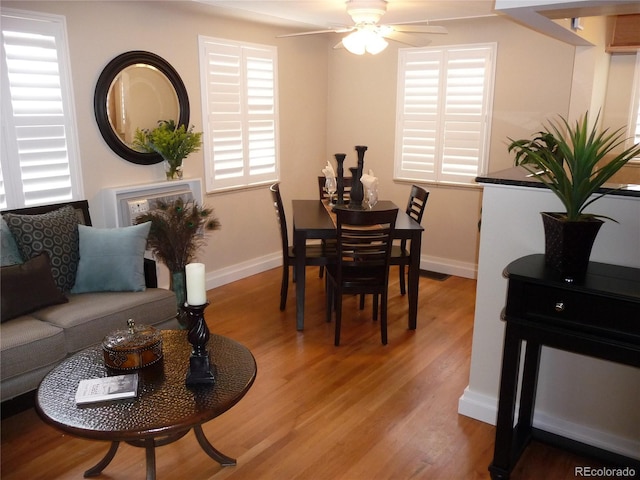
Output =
[{"x1": 269, "y1": 183, "x2": 335, "y2": 310}]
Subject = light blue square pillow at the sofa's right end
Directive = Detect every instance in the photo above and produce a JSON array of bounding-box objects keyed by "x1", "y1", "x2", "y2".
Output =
[{"x1": 71, "y1": 222, "x2": 151, "y2": 293}]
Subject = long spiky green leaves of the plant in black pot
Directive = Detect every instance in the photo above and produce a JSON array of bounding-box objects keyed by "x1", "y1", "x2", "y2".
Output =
[{"x1": 508, "y1": 112, "x2": 640, "y2": 221}]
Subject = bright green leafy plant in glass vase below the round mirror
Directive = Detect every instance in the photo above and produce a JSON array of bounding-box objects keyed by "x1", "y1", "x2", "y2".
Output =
[{"x1": 133, "y1": 120, "x2": 202, "y2": 180}]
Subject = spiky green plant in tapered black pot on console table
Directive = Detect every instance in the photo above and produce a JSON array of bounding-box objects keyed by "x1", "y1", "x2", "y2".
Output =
[{"x1": 508, "y1": 113, "x2": 640, "y2": 281}]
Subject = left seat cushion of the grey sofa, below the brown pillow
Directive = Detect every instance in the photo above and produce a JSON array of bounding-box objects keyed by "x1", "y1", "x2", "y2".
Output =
[{"x1": 0, "y1": 315, "x2": 67, "y2": 382}]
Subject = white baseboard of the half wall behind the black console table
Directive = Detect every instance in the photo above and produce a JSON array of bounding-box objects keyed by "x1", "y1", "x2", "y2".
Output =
[{"x1": 458, "y1": 387, "x2": 640, "y2": 460}]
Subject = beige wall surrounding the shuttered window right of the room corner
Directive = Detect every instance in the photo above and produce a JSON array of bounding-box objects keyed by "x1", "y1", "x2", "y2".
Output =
[{"x1": 327, "y1": 17, "x2": 574, "y2": 276}]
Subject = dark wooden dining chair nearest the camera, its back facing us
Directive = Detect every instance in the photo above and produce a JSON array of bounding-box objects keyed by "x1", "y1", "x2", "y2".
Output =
[{"x1": 325, "y1": 208, "x2": 398, "y2": 346}]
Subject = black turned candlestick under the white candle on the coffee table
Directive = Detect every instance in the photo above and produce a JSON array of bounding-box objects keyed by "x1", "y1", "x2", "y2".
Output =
[{"x1": 183, "y1": 302, "x2": 215, "y2": 385}]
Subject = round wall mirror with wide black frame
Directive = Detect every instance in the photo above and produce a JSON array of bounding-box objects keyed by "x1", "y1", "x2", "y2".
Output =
[{"x1": 93, "y1": 50, "x2": 189, "y2": 165}]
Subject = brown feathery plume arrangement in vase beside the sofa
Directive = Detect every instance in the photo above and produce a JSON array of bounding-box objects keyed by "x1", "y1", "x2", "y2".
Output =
[{"x1": 136, "y1": 198, "x2": 220, "y2": 324}]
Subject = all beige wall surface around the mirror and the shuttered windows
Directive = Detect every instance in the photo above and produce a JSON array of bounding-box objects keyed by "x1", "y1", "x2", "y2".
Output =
[{"x1": 3, "y1": 1, "x2": 632, "y2": 282}]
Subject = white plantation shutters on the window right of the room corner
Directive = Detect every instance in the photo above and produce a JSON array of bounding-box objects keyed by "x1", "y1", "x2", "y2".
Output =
[{"x1": 395, "y1": 44, "x2": 496, "y2": 183}]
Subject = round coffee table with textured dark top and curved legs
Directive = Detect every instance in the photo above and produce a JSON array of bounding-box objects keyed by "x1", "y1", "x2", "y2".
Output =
[{"x1": 36, "y1": 330, "x2": 256, "y2": 480}]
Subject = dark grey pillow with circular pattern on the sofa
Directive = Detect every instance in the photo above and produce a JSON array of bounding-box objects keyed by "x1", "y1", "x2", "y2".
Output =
[{"x1": 4, "y1": 205, "x2": 80, "y2": 292}]
